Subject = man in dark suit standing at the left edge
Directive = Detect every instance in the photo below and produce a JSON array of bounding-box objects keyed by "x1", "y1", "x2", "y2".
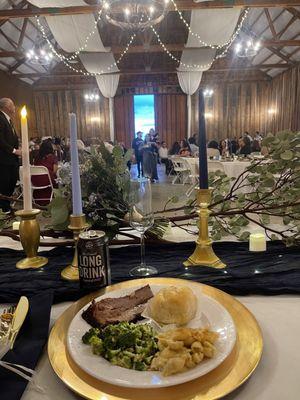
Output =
[{"x1": 0, "y1": 98, "x2": 22, "y2": 213}]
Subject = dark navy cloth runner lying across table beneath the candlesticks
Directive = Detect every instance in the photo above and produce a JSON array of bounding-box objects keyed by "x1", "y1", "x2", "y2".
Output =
[{"x1": 0, "y1": 242, "x2": 300, "y2": 303}]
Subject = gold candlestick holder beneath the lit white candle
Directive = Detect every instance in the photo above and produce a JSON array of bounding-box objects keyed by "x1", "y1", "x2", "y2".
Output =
[{"x1": 15, "y1": 209, "x2": 48, "y2": 269}]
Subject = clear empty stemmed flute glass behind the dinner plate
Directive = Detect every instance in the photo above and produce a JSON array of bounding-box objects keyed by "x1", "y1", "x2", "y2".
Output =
[{"x1": 129, "y1": 178, "x2": 158, "y2": 276}]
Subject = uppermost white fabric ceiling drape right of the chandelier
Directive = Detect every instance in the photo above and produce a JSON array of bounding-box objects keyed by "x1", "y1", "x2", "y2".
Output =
[{"x1": 186, "y1": 8, "x2": 240, "y2": 47}]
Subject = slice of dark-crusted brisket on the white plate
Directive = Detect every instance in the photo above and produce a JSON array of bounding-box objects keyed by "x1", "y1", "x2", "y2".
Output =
[{"x1": 82, "y1": 285, "x2": 153, "y2": 328}]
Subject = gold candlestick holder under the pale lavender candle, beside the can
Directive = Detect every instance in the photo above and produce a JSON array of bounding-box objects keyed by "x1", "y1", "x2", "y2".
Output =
[{"x1": 61, "y1": 214, "x2": 89, "y2": 281}]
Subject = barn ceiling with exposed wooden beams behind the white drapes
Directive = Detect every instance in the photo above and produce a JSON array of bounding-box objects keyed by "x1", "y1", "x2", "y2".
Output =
[{"x1": 0, "y1": 0, "x2": 300, "y2": 84}]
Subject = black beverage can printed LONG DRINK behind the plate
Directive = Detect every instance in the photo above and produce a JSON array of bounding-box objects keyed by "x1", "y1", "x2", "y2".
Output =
[{"x1": 77, "y1": 231, "x2": 110, "y2": 290}]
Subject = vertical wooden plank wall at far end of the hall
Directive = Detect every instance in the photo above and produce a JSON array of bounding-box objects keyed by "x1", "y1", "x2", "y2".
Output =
[{"x1": 32, "y1": 66, "x2": 300, "y2": 146}]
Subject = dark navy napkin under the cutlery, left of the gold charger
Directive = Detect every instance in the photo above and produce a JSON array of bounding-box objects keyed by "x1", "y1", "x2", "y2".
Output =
[{"x1": 0, "y1": 290, "x2": 53, "y2": 400}]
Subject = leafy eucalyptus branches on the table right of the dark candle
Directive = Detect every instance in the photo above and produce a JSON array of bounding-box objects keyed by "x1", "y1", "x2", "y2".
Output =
[{"x1": 161, "y1": 131, "x2": 300, "y2": 245}]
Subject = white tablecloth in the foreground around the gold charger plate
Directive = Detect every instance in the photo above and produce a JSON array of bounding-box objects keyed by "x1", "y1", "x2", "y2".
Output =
[{"x1": 18, "y1": 296, "x2": 300, "y2": 400}]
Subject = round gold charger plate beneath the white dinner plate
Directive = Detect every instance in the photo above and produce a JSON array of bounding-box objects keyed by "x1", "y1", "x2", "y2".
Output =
[{"x1": 48, "y1": 278, "x2": 263, "y2": 400}]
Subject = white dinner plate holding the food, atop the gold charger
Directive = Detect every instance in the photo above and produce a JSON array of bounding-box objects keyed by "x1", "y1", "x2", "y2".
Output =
[{"x1": 67, "y1": 283, "x2": 236, "y2": 388}]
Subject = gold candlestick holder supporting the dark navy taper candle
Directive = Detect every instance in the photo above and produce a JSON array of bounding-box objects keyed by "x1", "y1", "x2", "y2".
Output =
[{"x1": 183, "y1": 189, "x2": 226, "y2": 268}]
